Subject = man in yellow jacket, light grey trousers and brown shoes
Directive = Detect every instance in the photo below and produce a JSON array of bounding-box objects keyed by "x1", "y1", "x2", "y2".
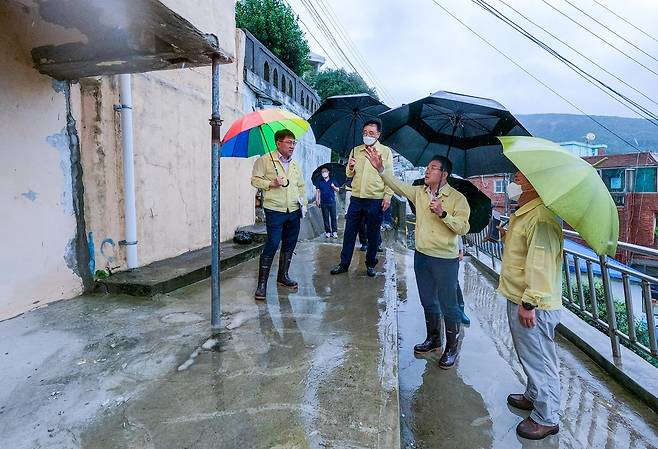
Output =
[{"x1": 498, "y1": 172, "x2": 564, "y2": 440}]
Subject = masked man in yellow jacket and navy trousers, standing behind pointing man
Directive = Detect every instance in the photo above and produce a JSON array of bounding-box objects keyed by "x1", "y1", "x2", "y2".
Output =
[{"x1": 331, "y1": 119, "x2": 393, "y2": 277}]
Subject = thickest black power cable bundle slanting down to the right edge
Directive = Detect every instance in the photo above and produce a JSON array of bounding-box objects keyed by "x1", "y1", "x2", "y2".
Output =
[{"x1": 472, "y1": 0, "x2": 658, "y2": 127}]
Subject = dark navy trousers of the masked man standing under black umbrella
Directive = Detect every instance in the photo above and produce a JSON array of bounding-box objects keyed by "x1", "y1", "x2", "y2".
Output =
[{"x1": 340, "y1": 196, "x2": 382, "y2": 267}]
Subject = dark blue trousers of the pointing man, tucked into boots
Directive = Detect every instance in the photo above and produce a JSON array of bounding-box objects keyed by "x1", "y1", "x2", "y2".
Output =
[{"x1": 414, "y1": 251, "x2": 461, "y2": 323}]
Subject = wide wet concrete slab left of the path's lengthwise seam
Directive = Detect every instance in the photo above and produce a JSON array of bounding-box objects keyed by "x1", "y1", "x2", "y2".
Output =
[{"x1": 0, "y1": 243, "x2": 400, "y2": 449}]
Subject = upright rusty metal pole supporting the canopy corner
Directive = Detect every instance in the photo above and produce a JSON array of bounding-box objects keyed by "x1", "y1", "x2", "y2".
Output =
[{"x1": 210, "y1": 55, "x2": 222, "y2": 334}]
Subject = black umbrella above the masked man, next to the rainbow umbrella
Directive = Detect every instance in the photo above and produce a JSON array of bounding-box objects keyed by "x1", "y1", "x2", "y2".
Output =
[{"x1": 308, "y1": 94, "x2": 389, "y2": 157}]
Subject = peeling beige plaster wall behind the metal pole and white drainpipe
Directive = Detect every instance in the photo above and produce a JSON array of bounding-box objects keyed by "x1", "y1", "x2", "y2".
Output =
[{"x1": 81, "y1": 2, "x2": 255, "y2": 269}]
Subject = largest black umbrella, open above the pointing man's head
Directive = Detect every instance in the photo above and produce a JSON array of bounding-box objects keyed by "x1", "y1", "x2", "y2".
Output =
[{"x1": 380, "y1": 91, "x2": 530, "y2": 178}]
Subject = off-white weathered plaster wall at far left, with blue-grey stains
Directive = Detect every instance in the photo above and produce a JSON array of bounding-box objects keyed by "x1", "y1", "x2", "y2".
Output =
[{"x1": 0, "y1": 2, "x2": 82, "y2": 319}]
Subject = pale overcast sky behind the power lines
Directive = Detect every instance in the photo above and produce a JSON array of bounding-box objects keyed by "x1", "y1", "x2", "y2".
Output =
[{"x1": 288, "y1": 0, "x2": 658, "y2": 117}]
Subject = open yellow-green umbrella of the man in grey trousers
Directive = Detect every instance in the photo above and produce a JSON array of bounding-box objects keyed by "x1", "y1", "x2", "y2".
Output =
[{"x1": 498, "y1": 136, "x2": 619, "y2": 256}]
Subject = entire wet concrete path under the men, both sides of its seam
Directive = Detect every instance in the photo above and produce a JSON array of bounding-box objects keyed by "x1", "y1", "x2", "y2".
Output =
[{"x1": 0, "y1": 242, "x2": 658, "y2": 449}]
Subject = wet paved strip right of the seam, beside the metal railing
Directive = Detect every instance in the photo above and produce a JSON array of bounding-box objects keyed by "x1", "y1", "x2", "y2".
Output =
[{"x1": 398, "y1": 253, "x2": 658, "y2": 449}]
